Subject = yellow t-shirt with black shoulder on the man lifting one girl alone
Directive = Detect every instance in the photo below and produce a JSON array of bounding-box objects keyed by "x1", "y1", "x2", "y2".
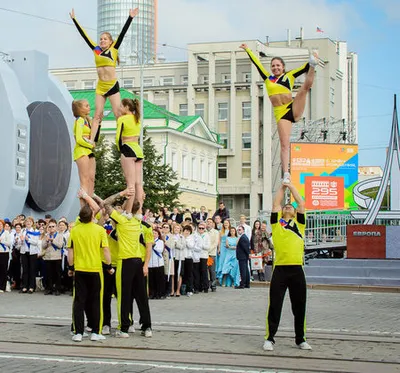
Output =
[{"x1": 271, "y1": 212, "x2": 306, "y2": 266}]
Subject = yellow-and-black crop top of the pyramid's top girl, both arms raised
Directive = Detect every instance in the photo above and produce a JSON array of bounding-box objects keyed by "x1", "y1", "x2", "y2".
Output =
[{"x1": 73, "y1": 16, "x2": 133, "y2": 67}]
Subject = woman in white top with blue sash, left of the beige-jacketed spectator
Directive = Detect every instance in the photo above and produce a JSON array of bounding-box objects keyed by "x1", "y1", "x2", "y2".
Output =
[{"x1": 20, "y1": 216, "x2": 40, "y2": 294}]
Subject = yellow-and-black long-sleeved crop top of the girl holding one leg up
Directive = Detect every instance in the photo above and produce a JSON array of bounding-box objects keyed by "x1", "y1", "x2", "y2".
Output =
[{"x1": 246, "y1": 48, "x2": 310, "y2": 96}]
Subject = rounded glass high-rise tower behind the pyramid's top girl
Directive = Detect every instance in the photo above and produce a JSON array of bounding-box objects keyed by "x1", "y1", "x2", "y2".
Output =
[{"x1": 97, "y1": 0, "x2": 158, "y2": 65}]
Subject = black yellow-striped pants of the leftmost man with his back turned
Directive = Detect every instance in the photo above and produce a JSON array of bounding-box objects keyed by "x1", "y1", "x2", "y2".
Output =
[{"x1": 72, "y1": 271, "x2": 103, "y2": 334}]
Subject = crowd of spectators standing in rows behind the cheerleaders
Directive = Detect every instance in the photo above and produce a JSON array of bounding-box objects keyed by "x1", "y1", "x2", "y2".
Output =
[{"x1": 0, "y1": 201, "x2": 272, "y2": 299}]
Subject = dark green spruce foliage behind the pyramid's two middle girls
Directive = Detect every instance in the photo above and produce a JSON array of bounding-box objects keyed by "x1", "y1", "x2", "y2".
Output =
[{"x1": 94, "y1": 135, "x2": 181, "y2": 211}]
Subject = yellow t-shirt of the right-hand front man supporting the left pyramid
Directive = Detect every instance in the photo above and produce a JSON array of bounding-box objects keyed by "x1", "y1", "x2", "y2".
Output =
[{"x1": 110, "y1": 210, "x2": 143, "y2": 259}]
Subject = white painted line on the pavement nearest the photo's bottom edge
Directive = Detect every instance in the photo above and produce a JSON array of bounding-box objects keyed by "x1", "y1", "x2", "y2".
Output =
[{"x1": 0, "y1": 354, "x2": 276, "y2": 373}]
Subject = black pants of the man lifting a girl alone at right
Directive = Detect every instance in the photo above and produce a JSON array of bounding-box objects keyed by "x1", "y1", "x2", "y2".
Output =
[{"x1": 266, "y1": 265, "x2": 307, "y2": 344}]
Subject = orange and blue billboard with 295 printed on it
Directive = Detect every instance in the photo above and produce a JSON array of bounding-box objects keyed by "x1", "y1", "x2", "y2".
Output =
[{"x1": 290, "y1": 143, "x2": 358, "y2": 210}]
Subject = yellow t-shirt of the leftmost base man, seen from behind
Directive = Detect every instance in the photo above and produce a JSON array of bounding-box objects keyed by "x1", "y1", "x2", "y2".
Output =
[{"x1": 68, "y1": 222, "x2": 108, "y2": 272}]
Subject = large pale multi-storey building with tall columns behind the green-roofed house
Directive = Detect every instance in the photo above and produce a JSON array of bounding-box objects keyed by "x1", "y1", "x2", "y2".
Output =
[{"x1": 53, "y1": 39, "x2": 357, "y2": 220}]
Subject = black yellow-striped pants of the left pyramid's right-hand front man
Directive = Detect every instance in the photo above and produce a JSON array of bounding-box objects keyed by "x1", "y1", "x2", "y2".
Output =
[{"x1": 116, "y1": 258, "x2": 152, "y2": 333}]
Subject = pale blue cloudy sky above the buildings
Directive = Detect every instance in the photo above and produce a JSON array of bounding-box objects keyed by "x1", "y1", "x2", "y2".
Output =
[{"x1": 0, "y1": 0, "x2": 400, "y2": 166}]
